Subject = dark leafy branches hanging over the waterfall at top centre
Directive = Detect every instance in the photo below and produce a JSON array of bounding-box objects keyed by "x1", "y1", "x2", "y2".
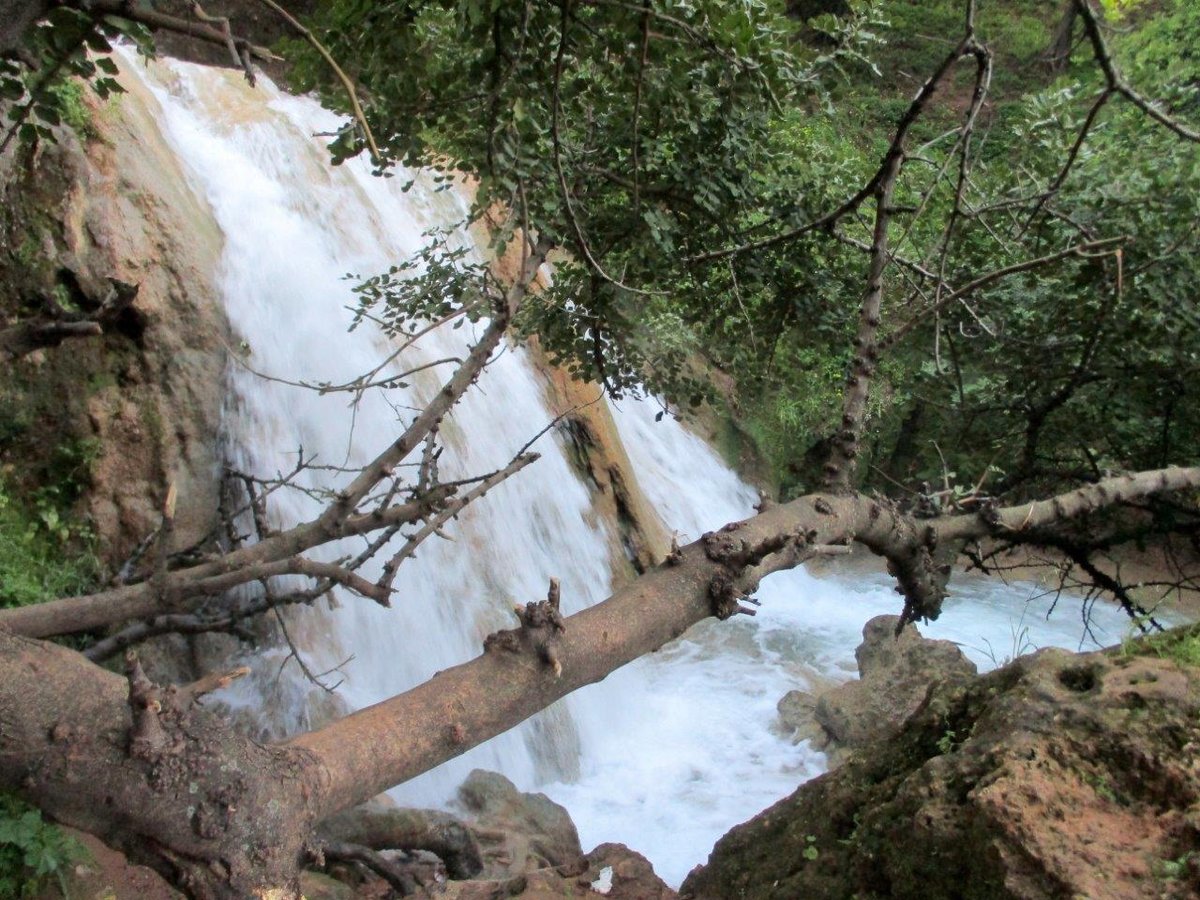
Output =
[{"x1": 300, "y1": 0, "x2": 892, "y2": 400}]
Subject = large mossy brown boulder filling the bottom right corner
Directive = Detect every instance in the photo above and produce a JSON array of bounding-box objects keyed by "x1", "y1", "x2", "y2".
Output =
[{"x1": 680, "y1": 650, "x2": 1200, "y2": 900}]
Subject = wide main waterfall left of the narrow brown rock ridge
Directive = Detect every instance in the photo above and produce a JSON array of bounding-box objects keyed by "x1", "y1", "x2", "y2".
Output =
[{"x1": 127, "y1": 62, "x2": 611, "y2": 805}]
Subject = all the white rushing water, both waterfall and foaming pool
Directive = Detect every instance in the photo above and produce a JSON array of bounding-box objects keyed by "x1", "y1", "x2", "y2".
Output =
[{"x1": 129, "y1": 54, "x2": 1142, "y2": 884}]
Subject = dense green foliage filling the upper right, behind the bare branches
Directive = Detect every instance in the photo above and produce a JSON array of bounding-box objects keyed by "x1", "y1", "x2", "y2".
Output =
[{"x1": 290, "y1": 0, "x2": 1200, "y2": 508}]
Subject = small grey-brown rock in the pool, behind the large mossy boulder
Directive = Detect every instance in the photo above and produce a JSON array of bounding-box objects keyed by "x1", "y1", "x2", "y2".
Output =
[{"x1": 779, "y1": 616, "x2": 977, "y2": 764}]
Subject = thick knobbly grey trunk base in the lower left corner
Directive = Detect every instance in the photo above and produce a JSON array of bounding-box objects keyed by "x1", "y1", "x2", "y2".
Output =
[{"x1": 0, "y1": 631, "x2": 322, "y2": 898}]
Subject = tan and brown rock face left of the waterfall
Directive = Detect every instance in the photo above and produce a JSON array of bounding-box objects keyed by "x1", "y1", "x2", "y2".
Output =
[{"x1": 0, "y1": 60, "x2": 229, "y2": 565}]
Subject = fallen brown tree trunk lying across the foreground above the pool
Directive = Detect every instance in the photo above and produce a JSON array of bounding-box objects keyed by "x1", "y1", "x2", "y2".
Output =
[{"x1": 0, "y1": 468, "x2": 1200, "y2": 898}]
